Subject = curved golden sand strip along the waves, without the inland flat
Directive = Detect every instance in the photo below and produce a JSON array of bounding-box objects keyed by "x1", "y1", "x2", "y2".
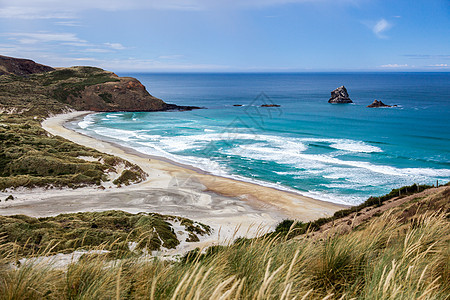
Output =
[{"x1": 42, "y1": 111, "x2": 346, "y2": 216}]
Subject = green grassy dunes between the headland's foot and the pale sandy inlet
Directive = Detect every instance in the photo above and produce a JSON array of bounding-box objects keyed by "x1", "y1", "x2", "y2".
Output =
[{"x1": 0, "y1": 114, "x2": 145, "y2": 190}]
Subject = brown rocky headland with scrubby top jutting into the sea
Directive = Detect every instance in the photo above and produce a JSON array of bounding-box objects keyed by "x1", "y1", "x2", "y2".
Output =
[{"x1": 0, "y1": 58, "x2": 199, "y2": 116}]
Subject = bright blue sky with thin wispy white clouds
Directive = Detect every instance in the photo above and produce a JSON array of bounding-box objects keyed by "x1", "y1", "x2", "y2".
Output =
[{"x1": 0, "y1": 0, "x2": 450, "y2": 72}]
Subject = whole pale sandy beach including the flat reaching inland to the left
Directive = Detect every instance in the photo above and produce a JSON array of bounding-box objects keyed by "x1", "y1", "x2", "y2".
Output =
[{"x1": 0, "y1": 112, "x2": 343, "y2": 250}]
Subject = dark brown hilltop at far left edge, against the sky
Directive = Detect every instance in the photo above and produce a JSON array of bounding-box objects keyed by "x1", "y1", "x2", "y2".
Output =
[{"x1": 0, "y1": 55, "x2": 54, "y2": 76}]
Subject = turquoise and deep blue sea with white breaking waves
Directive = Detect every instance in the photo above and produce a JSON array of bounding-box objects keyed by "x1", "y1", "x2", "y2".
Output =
[{"x1": 71, "y1": 73, "x2": 450, "y2": 204}]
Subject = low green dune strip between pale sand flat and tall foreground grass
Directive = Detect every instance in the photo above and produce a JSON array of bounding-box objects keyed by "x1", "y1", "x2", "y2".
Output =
[{"x1": 0, "y1": 211, "x2": 211, "y2": 257}]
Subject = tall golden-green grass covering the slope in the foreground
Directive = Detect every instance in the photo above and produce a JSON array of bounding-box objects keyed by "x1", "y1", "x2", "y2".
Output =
[{"x1": 0, "y1": 188, "x2": 450, "y2": 299}]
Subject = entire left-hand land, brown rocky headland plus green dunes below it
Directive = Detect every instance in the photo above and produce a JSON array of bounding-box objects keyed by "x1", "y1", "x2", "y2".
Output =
[{"x1": 0, "y1": 56, "x2": 198, "y2": 190}]
